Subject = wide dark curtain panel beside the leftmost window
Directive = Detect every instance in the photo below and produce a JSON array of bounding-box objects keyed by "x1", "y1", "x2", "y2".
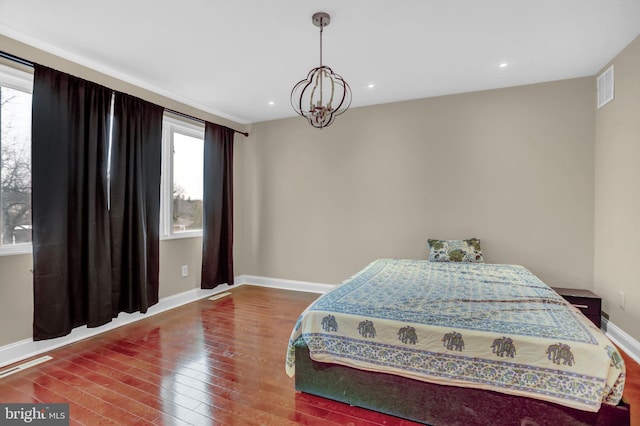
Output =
[{"x1": 31, "y1": 64, "x2": 112, "y2": 340}]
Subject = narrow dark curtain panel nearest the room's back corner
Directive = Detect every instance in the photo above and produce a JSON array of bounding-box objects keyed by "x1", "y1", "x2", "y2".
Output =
[{"x1": 201, "y1": 123, "x2": 235, "y2": 288}]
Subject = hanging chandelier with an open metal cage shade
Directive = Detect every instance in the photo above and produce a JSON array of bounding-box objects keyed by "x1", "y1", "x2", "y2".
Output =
[{"x1": 291, "y1": 12, "x2": 351, "y2": 128}]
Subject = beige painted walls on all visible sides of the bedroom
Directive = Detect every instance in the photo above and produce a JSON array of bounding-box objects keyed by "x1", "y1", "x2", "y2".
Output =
[{"x1": 0, "y1": 30, "x2": 640, "y2": 346}]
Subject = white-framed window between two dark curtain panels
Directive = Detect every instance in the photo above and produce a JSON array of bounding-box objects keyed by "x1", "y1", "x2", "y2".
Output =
[{"x1": 160, "y1": 114, "x2": 204, "y2": 238}]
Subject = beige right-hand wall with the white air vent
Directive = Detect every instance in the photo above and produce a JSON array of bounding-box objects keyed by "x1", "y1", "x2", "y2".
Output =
[{"x1": 594, "y1": 37, "x2": 640, "y2": 341}]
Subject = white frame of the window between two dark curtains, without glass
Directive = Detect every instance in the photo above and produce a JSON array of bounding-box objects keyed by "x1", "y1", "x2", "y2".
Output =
[{"x1": 159, "y1": 112, "x2": 204, "y2": 240}]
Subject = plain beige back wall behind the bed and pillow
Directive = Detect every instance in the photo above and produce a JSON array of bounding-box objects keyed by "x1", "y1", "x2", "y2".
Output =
[{"x1": 241, "y1": 78, "x2": 594, "y2": 288}]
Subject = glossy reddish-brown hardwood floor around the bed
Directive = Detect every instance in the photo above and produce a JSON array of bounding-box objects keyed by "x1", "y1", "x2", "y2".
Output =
[{"x1": 0, "y1": 286, "x2": 640, "y2": 426}]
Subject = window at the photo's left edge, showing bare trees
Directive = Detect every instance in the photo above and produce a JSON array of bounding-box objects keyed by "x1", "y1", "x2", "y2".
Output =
[{"x1": 0, "y1": 64, "x2": 33, "y2": 254}]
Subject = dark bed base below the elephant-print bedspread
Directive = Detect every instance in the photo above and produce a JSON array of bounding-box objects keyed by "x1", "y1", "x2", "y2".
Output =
[{"x1": 295, "y1": 346, "x2": 630, "y2": 426}]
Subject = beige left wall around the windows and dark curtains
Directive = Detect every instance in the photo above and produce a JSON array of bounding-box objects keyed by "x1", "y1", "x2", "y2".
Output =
[{"x1": 0, "y1": 36, "x2": 246, "y2": 346}]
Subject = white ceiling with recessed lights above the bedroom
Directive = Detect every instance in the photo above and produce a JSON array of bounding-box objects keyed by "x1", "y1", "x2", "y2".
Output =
[{"x1": 0, "y1": 0, "x2": 640, "y2": 123}]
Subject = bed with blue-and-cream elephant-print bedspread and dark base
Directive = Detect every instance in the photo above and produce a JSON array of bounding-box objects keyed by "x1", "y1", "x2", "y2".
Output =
[{"x1": 286, "y1": 259, "x2": 629, "y2": 425}]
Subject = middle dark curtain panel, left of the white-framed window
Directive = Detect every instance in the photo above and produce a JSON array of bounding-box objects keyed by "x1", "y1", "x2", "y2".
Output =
[{"x1": 110, "y1": 93, "x2": 164, "y2": 315}]
